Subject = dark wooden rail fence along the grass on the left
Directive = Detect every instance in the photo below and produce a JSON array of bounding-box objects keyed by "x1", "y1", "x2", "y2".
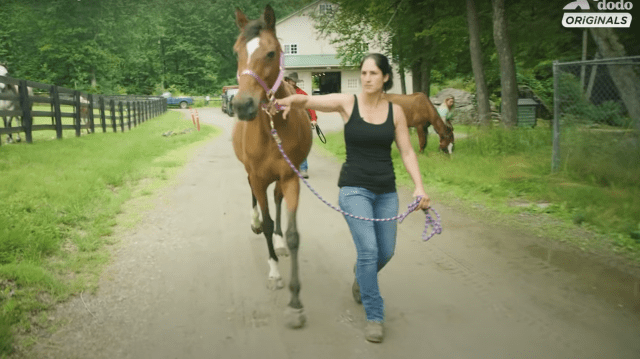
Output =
[{"x1": 0, "y1": 76, "x2": 167, "y2": 143}]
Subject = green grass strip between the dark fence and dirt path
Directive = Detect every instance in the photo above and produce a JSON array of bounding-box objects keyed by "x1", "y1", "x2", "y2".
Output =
[{"x1": 0, "y1": 111, "x2": 219, "y2": 356}]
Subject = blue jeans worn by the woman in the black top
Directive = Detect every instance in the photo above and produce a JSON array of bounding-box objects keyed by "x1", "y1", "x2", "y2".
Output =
[{"x1": 339, "y1": 187, "x2": 398, "y2": 322}]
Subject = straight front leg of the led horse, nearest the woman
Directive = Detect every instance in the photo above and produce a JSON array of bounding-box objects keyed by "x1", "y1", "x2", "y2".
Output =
[{"x1": 282, "y1": 177, "x2": 307, "y2": 328}]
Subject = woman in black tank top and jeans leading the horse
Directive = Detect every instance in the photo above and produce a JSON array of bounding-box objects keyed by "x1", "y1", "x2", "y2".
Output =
[{"x1": 278, "y1": 54, "x2": 430, "y2": 343}]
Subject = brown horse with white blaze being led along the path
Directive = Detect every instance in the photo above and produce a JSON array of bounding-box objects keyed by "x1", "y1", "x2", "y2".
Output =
[{"x1": 233, "y1": 5, "x2": 311, "y2": 328}]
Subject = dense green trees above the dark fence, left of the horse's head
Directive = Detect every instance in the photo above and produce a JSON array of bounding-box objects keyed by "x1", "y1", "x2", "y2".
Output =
[{"x1": 0, "y1": 0, "x2": 308, "y2": 95}]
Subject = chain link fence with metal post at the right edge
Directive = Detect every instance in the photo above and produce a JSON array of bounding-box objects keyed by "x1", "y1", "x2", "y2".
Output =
[{"x1": 552, "y1": 56, "x2": 640, "y2": 185}]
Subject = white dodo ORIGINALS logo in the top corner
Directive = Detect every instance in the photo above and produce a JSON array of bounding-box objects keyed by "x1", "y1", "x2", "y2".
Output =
[{"x1": 562, "y1": 0, "x2": 633, "y2": 27}]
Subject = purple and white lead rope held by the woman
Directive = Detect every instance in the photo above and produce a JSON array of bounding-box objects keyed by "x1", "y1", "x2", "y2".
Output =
[{"x1": 271, "y1": 127, "x2": 442, "y2": 241}]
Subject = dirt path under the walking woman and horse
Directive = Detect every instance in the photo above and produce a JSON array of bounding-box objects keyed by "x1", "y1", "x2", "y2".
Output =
[{"x1": 29, "y1": 109, "x2": 640, "y2": 359}]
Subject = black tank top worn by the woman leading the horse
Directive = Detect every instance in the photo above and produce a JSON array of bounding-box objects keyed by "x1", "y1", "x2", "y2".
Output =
[{"x1": 338, "y1": 95, "x2": 396, "y2": 194}]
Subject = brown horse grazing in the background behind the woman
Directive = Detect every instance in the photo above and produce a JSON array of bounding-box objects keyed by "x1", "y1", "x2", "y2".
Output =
[{"x1": 385, "y1": 92, "x2": 454, "y2": 154}]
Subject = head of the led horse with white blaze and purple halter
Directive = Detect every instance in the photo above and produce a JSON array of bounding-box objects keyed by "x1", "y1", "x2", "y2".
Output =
[{"x1": 232, "y1": 5, "x2": 284, "y2": 121}]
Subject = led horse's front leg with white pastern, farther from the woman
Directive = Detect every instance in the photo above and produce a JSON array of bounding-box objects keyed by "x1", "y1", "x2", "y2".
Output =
[{"x1": 250, "y1": 178, "x2": 284, "y2": 290}]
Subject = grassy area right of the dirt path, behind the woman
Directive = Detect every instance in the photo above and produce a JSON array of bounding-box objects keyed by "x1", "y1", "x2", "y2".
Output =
[{"x1": 316, "y1": 121, "x2": 640, "y2": 262}]
